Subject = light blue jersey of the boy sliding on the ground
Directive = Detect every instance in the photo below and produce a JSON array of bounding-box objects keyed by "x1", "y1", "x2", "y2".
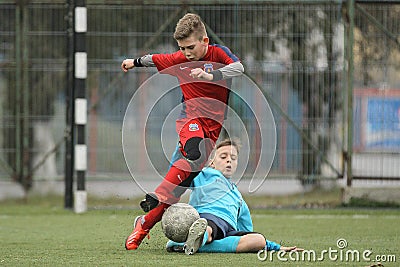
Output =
[{"x1": 189, "y1": 168, "x2": 253, "y2": 232}]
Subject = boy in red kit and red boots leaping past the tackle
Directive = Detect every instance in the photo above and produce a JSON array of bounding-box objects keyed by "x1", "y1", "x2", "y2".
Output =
[{"x1": 121, "y1": 13, "x2": 244, "y2": 250}]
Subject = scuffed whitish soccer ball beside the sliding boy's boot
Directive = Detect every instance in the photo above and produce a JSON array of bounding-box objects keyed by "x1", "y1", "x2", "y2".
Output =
[{"x1": 161, "y1": 203, "x2": 200, "y2": 243}]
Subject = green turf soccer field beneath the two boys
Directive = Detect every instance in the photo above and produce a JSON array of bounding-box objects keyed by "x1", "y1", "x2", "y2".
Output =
[{"x1": 0, "y1": 198, "x2": 400, "y2": 267}]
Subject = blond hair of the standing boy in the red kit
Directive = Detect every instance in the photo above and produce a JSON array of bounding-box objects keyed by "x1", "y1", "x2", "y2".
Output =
[{"x1": 174, "y1": 13, "x2": 207, "y2": 41}]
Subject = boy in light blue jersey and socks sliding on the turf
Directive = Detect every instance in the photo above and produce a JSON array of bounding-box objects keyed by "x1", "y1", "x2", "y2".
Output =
[{"x1": 167, "y1": 139, "x2": 302, "y2": 255}]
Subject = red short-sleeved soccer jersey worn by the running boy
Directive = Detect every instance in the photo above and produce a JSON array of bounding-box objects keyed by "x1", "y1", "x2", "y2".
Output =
[{"x1": 152, "y1": 45, "x2": 239, "y2": 131}]
